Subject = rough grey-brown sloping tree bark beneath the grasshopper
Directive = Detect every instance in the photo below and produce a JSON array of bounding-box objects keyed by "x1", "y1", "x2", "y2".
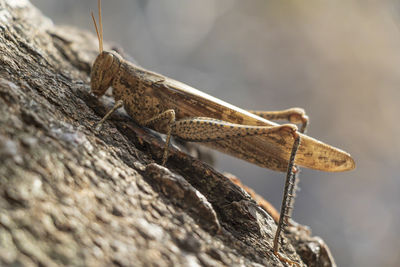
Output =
[{"x1": 0, "y1": 0, "x2": 334, "y2": 266}]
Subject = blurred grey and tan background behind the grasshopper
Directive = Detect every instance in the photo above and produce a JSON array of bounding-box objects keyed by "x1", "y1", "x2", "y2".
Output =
[{"x1": 31, "y1": 0, "x2": 400, "y2": 266}]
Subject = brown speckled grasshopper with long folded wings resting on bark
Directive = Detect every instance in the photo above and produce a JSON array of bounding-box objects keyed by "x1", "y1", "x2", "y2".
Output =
[{"x1": 91, "y1": 0, "x2": 355, "y2": 265}]
